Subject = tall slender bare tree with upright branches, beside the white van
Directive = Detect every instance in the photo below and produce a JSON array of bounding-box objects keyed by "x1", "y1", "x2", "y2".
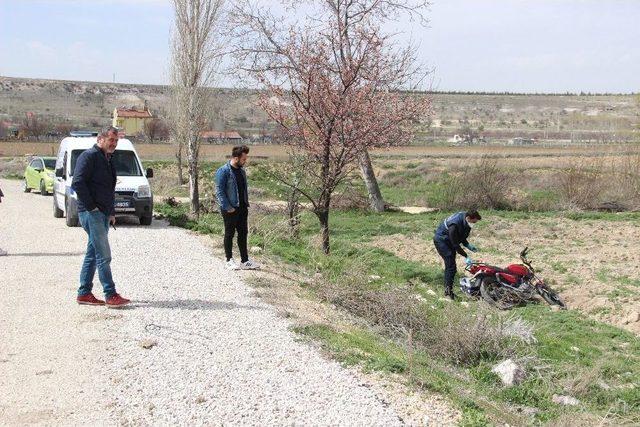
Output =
[{"x1": 171, "y1": 0, "x2": 224, "y2": 215}]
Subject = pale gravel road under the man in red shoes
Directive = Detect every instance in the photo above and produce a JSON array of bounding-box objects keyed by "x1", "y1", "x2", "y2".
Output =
[{"x1": 0, "y1": 180, "x2": 402, "y2": 426}]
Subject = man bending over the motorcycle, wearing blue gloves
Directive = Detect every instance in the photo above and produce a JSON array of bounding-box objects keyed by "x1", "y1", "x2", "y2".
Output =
[{"x1": 433, "y1": 210, "x2": 482, "y2": 300}]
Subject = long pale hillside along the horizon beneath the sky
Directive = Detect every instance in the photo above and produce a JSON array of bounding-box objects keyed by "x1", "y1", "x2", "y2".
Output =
[{"x1": 0, "y1": 77, "x2": 640, "y2": 144}]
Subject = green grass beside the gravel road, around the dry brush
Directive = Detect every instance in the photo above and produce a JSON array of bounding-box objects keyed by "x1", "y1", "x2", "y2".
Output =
[{"x1": 157, "y1": 204, "x2": 640, "y2": 425}]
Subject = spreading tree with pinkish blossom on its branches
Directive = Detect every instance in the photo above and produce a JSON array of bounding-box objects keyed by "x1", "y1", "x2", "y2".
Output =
[{"x1": 234, "y1": 1, "x2": 429, "y2": 253}]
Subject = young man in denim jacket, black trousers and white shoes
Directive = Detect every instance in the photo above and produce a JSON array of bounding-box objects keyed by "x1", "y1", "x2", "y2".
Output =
[{"x1": 216, "y1": 145, "x2": 260, "y2": 270}]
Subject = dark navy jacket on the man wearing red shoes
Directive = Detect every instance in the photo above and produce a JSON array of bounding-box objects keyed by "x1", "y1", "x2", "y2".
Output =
[{"x1": 71, "y1": 145, "x2": 117, "y2": 215}]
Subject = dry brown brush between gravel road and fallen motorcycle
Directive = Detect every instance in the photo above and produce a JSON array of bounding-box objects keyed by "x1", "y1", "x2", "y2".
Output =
[{"x1": 313, "y1": 256, "x2": 526, "y2": 365}]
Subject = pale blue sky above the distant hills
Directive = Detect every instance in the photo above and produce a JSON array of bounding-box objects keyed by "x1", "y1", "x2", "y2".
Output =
[{"x1": 0, "y1": 0, "x2": 640, "y2": 92}]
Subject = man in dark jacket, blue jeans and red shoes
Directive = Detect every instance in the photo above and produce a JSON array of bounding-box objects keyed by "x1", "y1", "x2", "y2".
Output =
[{"x1": 71, "y1": 127, "x2": 130, "y2": 307}]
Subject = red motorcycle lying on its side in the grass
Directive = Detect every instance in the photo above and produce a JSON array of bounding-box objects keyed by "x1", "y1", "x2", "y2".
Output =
[{"x1": 460, "y1": 248, "x2": 567, "y2": 310}]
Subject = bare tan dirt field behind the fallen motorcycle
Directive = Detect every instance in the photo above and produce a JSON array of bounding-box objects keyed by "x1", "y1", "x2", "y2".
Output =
[{"x1": 370, "y1": 218, "x2": 640, "y2": 334}]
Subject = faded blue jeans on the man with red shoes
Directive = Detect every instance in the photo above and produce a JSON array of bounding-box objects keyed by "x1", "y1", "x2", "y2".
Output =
[{"x1": 78, "y1": 211, "x2": 116, "y2": 298}]
